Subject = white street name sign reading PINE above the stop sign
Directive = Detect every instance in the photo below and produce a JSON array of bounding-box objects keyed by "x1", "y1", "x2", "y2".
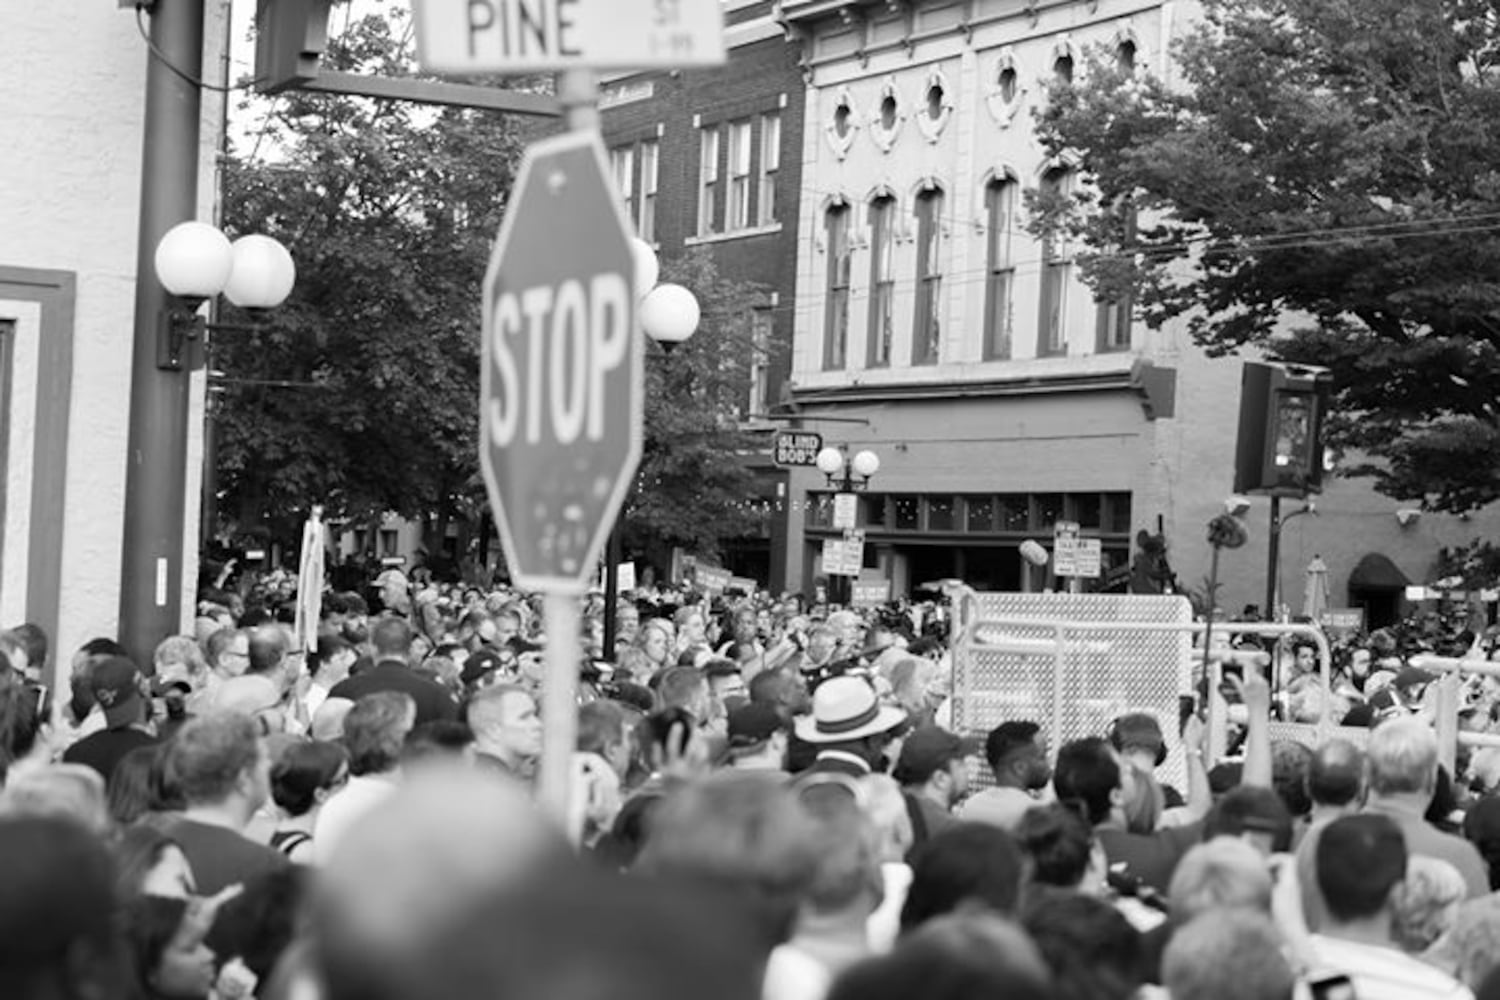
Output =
[{"x1": 413, "y1": 0, "x2": 725, "y2": 73}]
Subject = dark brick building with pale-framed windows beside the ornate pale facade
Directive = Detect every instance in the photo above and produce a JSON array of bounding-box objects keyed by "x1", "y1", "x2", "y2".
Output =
[{"x1": 600, "y1": 0, "x2": 804, "y2": 589}]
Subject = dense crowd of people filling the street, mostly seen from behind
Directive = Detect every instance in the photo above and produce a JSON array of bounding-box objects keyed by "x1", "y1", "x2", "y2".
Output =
[{"x1": 0, "y1": 571, "x2": 1500, "y2": 1000}]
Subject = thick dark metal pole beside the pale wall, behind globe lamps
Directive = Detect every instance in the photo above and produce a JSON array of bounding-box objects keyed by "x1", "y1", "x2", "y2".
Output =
[{"x1": 120, "y1": 0, "x2": 206, "y2": 663}]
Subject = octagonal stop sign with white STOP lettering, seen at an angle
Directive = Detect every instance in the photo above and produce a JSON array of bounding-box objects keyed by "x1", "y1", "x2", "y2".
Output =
[{"x1": 480, "y1": 132, "x2": 642, "y2": 591}]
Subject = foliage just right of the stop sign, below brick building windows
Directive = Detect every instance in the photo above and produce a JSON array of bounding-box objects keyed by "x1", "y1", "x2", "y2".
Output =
[{"x1": 624, "y1": 247, "x2": 774, "y2": 558}]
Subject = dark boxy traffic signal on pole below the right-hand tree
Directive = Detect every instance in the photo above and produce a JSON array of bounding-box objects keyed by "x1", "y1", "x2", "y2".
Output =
[{"x1": 1235, "y1": 361, "x2": 1334, "y2": 496}]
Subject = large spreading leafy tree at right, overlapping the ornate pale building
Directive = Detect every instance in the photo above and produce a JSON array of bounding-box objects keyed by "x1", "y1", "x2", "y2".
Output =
[{"x1": 1032, "y1": 0, "x2": 1500, "y2": 511}]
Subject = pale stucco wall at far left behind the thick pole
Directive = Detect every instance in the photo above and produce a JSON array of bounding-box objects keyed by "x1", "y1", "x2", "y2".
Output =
[{"x1": 0, "y1": 0, "x2": 225, "y2": 671}]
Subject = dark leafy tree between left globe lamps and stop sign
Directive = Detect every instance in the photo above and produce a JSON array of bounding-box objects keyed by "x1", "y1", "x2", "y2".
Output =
[{"x1": 212, "y1": 7, "x2": 525, "y2": 551}]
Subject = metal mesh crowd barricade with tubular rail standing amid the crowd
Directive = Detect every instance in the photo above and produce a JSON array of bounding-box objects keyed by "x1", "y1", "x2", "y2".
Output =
[{"x1": 953, "y1": 591, "x2": 1335, "y2": 781}]
